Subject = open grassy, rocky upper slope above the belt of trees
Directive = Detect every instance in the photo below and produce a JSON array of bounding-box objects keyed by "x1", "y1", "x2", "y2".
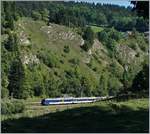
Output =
[{"x1": 16, "y1": 18, "x2": 148, "y2": 96}]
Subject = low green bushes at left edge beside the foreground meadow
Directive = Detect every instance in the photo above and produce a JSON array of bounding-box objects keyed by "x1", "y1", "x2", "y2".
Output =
[{"x1": 1, "y1": 100, "x2": 25, "y2": 114}]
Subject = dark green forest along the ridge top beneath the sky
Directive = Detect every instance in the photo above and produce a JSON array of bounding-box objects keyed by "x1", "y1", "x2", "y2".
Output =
[{"x1": 2, "y1": 2, "x2": 148, "y2": 31}]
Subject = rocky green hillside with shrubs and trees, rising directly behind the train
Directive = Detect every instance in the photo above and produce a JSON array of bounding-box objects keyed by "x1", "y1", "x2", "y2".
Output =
[{"x1": 1, "y1": 18, "x2": 148, "y2": 98}]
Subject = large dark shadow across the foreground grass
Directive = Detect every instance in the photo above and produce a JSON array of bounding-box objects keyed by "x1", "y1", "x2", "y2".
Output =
[{"x1": 2, "y1": 105, "x2": 149, "y2": 133}]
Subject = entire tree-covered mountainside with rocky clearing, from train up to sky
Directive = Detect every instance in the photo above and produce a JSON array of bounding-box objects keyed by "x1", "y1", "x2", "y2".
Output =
[{"x1": 1, "y1": 1, "x2": 149, "y2": 99}]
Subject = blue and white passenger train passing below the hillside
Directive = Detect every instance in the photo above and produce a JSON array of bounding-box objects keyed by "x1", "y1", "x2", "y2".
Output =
[{"x1": 41, "y1": 97, "x2": 107, "y2": 105}]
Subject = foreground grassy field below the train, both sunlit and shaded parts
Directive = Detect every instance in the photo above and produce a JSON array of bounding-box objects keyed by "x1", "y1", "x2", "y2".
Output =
[{"x1": 2, "y1": 99, "x2": 149, "y2": 133}]
